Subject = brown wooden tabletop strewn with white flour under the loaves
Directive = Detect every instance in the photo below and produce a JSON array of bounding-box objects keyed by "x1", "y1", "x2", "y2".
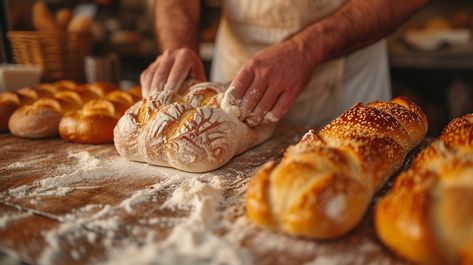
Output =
[{"x1": 0, "y1": 126, "x2": 404, "y2": 265}]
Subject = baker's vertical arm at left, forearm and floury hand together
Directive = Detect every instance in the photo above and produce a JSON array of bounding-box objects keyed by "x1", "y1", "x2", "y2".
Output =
[{"x1": 140, "y1": 0, "x2": 206, "y2": 98}]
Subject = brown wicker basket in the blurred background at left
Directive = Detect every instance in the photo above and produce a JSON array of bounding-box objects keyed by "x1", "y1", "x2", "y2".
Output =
[{"x1": 8, "y1": 31, "x2": 92, "y2": 82}]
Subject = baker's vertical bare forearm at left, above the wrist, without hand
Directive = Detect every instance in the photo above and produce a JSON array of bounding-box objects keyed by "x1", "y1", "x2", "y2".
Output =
[{"x1": 155, "y1": 0, "x2": 200, "y2": 52}]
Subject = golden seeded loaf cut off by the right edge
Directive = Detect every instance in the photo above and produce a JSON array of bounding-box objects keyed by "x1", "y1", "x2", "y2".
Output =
[{"x1": 375, "y1": 114, "x2": 473, "y2": 264}]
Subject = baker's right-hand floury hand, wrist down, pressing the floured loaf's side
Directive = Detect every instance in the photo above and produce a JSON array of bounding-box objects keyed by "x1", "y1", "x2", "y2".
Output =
[{"x1": 222, "y1": 38, "x2": 313, "y2": 126}]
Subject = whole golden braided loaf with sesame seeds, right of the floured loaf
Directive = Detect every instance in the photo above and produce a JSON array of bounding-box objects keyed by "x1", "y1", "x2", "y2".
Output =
[{"x1": 246, "y1": 98, "x2": 427, "y2": 239}]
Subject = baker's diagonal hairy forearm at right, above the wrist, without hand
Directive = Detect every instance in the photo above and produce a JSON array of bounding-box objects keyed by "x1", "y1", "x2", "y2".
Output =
[{"x1": 288, "y1": 0, "x2": 428, "y2": 67}]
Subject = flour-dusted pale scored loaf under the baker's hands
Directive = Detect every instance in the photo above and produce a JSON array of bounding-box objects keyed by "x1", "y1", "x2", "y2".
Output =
[{"x1": 114, "y1": 83, "x2": 274, "y2": 172}]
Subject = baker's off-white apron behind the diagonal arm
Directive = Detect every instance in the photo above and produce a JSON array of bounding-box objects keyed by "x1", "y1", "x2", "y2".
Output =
[{"x1": 211, "y1": 0, "x2": 390, "y2": 127}]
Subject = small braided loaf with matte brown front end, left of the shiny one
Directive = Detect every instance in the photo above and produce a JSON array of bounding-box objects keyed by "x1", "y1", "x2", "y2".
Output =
[{"x1": 8, "y1": 81, "x2": 116, "y2": 138}]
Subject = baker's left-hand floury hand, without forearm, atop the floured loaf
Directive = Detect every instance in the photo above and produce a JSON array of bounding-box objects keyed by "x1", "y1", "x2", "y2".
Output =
[{"x1": 140, "y1": 48, "x2": 206, "y2": 97}]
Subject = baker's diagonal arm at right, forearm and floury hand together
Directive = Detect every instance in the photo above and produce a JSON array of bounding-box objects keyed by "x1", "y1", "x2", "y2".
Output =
[{"x1": 227, "y1": 0, "x2": 428, "y2": 126}]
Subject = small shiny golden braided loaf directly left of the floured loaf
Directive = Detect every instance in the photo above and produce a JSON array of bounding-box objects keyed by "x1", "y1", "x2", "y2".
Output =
[{"x1": 59, "y1": 87, "x2": 141, "y2": 144}]
